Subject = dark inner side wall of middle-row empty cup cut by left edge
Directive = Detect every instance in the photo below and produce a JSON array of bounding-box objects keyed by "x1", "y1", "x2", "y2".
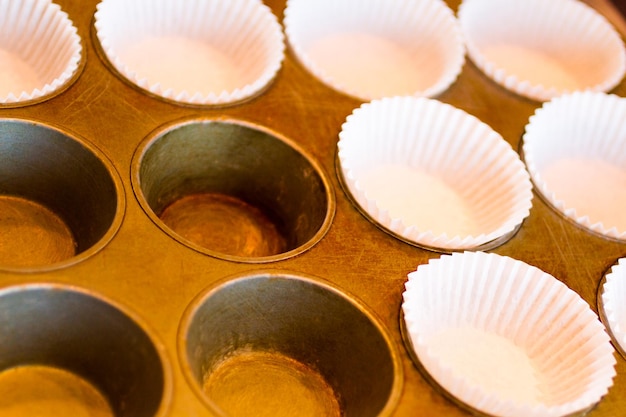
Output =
[{"x1": 0, "y1": 120, "x2": 123, "y2": 264}]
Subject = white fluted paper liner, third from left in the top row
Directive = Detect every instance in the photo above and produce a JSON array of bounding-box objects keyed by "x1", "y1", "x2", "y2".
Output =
[{"x1": 283, "y1": 0, "x2": 465, "y2": 101}]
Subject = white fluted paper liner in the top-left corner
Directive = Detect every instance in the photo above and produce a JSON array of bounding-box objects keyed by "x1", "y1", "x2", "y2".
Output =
[{"x1": 0, "y1": 0, "x2": 82, "y2": 104}]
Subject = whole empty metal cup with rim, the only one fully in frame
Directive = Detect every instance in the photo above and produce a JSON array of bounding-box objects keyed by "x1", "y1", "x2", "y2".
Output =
[{"x1": 132, "y1": 119, "x2": 335, "y2": 262}]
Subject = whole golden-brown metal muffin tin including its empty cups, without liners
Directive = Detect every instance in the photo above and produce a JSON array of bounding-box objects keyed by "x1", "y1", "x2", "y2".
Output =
[{"x1": 0, "y1": 0, "x2": 626, "y2": 417}]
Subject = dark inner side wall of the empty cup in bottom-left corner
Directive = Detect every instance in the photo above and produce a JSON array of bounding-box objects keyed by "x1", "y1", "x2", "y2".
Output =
[{"x1": 0, "y1": 284, "x2": 166, "y2": 417}]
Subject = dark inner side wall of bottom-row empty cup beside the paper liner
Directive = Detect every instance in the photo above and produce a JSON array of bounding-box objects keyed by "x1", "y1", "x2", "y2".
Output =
[{"x1": 179, "y1": 273, "x2": 402, "y2": 417}]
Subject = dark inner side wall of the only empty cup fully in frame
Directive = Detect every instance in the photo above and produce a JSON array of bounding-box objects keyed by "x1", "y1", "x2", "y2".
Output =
[{"x1": 133, "y1": 120, "x2": 334, "y2": 257}]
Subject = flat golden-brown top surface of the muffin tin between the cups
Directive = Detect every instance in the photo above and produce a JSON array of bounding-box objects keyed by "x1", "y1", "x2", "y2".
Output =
[{"x1": 0, "y1": 0, "x2": 626, "y2": 417}]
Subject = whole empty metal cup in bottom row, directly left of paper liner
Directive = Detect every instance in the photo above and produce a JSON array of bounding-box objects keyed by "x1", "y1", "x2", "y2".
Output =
[{"x1": 178, "y1": 271, "x2": 403, "y2": 417}]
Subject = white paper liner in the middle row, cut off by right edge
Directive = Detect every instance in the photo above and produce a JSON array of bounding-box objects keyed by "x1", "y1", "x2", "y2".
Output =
[{"x1": 523, "y1": 92, "x2": 626, "y2": 241}]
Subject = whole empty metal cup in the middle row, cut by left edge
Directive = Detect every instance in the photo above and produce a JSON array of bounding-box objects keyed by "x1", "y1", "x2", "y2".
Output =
[{"x1": 0, "y1": 119, "x2": 125, "y2": 270}]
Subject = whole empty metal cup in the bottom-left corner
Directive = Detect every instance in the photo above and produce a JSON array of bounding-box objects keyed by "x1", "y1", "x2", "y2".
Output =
[{"x1": 0, "y1": 284, "x2": 171, "y2": 417}]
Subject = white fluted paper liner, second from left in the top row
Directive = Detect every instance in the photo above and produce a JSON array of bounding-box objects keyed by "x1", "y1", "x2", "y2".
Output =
[{"x1": 95, "y1": 0, "x2": 285, "y2": 105}]
